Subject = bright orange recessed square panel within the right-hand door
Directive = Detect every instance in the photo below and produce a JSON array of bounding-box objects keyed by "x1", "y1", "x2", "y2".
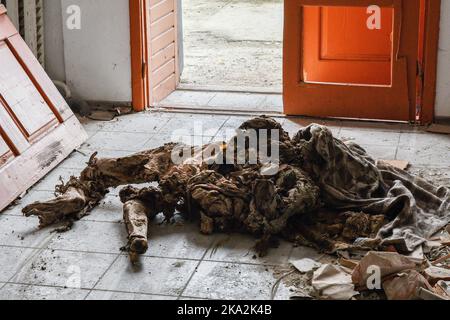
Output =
[{"x1": 303, "y1": 6, "x2": 393, "y2": 85}]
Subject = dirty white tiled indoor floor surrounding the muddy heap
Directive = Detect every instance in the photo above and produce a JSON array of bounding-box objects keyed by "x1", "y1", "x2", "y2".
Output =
[{"x1": 0, "y1": 112, "x2": 450, "y2": 299}]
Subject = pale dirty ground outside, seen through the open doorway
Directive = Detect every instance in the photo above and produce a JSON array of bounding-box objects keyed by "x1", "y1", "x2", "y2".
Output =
[{"x1": 181, "y1": 0, "x2": 283, "y2": 92}]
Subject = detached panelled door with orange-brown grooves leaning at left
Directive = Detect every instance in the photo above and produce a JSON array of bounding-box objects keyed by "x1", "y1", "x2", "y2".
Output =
[{"x1": 0, "y1": 5, "x2": 87, "y2": 211}]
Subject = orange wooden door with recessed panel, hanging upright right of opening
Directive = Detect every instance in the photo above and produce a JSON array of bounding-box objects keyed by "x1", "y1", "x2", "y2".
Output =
[{"x1": 284, "y1": 0, "x2": 420, "y2": 121}]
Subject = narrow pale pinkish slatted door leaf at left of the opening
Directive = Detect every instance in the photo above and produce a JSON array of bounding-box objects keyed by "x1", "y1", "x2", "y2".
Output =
[{"x1": 146, "y1": 0, "x2": 179, "y2": 106}]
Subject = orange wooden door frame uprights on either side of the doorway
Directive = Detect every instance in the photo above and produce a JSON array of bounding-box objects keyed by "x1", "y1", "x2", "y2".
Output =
[{"x1": 129, "y1": 0, "x2": 441, "y2": 124}]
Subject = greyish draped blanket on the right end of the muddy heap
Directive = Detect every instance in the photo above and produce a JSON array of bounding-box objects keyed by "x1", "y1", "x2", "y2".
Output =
[{"x1": 293, "y1": 125, "x2": 450, "y2": 252}]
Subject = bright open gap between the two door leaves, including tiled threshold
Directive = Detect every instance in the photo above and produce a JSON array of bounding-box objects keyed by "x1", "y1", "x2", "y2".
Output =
[{"x1": 157, "y1": 0, "x2": 283, "y2": 113}]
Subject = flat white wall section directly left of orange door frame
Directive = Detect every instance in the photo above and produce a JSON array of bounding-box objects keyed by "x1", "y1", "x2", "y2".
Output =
[{"x1": 59, "y1": 0, "x2": 132, "y2": 102}]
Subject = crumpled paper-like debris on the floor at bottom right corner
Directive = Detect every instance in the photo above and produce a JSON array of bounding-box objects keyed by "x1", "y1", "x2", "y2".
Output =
[{"x1": 286, "y1": 245, "x2": 450, "y2": 300}]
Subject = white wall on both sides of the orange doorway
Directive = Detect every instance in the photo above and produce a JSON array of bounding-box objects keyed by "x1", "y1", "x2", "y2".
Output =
[{"x1": 44, "y1": 0, "x2": 450, "y2": 117}]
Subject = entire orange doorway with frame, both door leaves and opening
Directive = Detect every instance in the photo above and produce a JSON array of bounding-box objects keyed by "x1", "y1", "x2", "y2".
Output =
[{"x1": 130, "y1": 0, "x2": 440, "y2": 123}]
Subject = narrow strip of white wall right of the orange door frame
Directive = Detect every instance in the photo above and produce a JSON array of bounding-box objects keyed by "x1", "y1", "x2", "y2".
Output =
[{"x1": 436, "y1": 0, "x2": 450, "y2": 117}]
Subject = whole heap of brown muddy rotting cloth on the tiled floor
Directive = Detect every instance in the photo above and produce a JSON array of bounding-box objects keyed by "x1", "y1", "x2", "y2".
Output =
[{"x1": 23, "y1": 117, "x2": 450, "y2": 259}]
